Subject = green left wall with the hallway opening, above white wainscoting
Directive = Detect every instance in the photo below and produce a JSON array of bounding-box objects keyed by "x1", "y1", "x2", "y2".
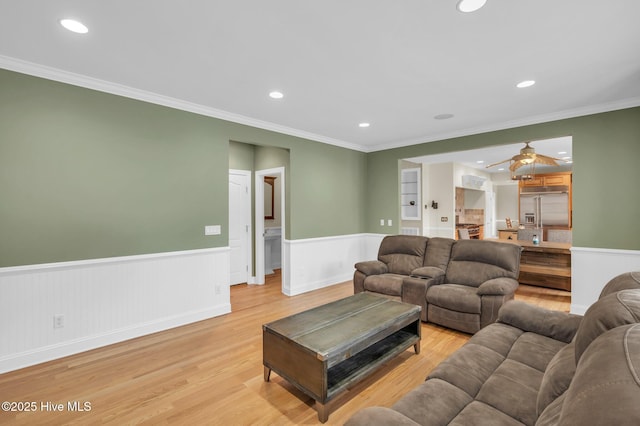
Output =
[{"x1": 0, "y1": 70, "x2": 366, "y2": 267}]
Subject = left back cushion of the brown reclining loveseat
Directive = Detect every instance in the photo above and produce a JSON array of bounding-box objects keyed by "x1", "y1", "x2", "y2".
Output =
[{"x1": 378, "y1": 235, "x2": 428, "y2": 275}]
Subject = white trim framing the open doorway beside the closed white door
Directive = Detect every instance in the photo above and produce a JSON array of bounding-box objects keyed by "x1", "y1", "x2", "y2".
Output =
[{"x1": 254, "y1": 167, "x2": 286, "y2": 284}]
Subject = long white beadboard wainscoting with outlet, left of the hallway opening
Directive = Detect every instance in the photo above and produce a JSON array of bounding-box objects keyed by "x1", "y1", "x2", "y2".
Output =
[{"x1": 0, "y1": 247, "x2": 231, "y2": 373}]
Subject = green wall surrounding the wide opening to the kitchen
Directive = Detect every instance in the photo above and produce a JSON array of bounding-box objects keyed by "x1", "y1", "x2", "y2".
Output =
[{"x1": 365, "y1": 108, "x2": 640, "y2": 250}]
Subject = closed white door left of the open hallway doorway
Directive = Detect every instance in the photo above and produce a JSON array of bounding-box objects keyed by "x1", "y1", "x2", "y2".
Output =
[{"x1": 229, "y1": 170, "x2": 251, "y2": 285}]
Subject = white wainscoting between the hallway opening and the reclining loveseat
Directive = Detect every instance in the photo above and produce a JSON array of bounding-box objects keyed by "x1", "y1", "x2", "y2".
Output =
[{"x1": 282, "y1": 234, "x2": 384, "y2": 296}]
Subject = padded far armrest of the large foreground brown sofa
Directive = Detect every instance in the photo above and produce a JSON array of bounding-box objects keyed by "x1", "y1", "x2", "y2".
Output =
[{"x1": 498, "y1": 300, "x2": 582, "y2": 343}]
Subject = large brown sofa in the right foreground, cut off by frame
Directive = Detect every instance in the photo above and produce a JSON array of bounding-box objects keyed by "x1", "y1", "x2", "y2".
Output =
[{"x1": 346, "y1": 272, "x2": 640, "y2": 426}]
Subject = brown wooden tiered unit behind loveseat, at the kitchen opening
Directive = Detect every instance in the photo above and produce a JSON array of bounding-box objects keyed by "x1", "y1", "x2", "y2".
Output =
[{"x1": 495, "y1": 240, "x2": 571, "y2": 291}]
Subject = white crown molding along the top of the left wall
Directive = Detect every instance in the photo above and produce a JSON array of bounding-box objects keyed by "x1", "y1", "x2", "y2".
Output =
[{"x1": 0, "y1": 55, "x2": 364, "y2": 151}]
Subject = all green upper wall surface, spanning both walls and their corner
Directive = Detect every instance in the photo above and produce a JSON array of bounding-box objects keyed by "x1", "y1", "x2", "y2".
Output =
[{"x1": 0, "y1": 70, "x2": 640, "y2": 267}]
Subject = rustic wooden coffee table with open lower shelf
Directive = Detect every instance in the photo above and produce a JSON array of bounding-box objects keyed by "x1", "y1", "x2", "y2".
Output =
[{"x1": 262, "y1": 293, "x2": 420, "y2": 423}]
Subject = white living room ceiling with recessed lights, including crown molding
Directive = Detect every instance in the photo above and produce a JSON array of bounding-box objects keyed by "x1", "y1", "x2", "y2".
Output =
[{"x1": 0, "y1": 0, "x2": 640, "y2": 152}]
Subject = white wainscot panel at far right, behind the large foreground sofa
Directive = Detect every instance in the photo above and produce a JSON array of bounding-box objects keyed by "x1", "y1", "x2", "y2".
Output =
[{"x1": 571, "y1": 247, "x2": 640, "y2": 315}]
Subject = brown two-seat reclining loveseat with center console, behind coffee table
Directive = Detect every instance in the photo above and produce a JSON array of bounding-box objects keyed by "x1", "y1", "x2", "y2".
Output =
[{"x1": 353, "y1": 235, "x2": 521, "y2": 333}]
